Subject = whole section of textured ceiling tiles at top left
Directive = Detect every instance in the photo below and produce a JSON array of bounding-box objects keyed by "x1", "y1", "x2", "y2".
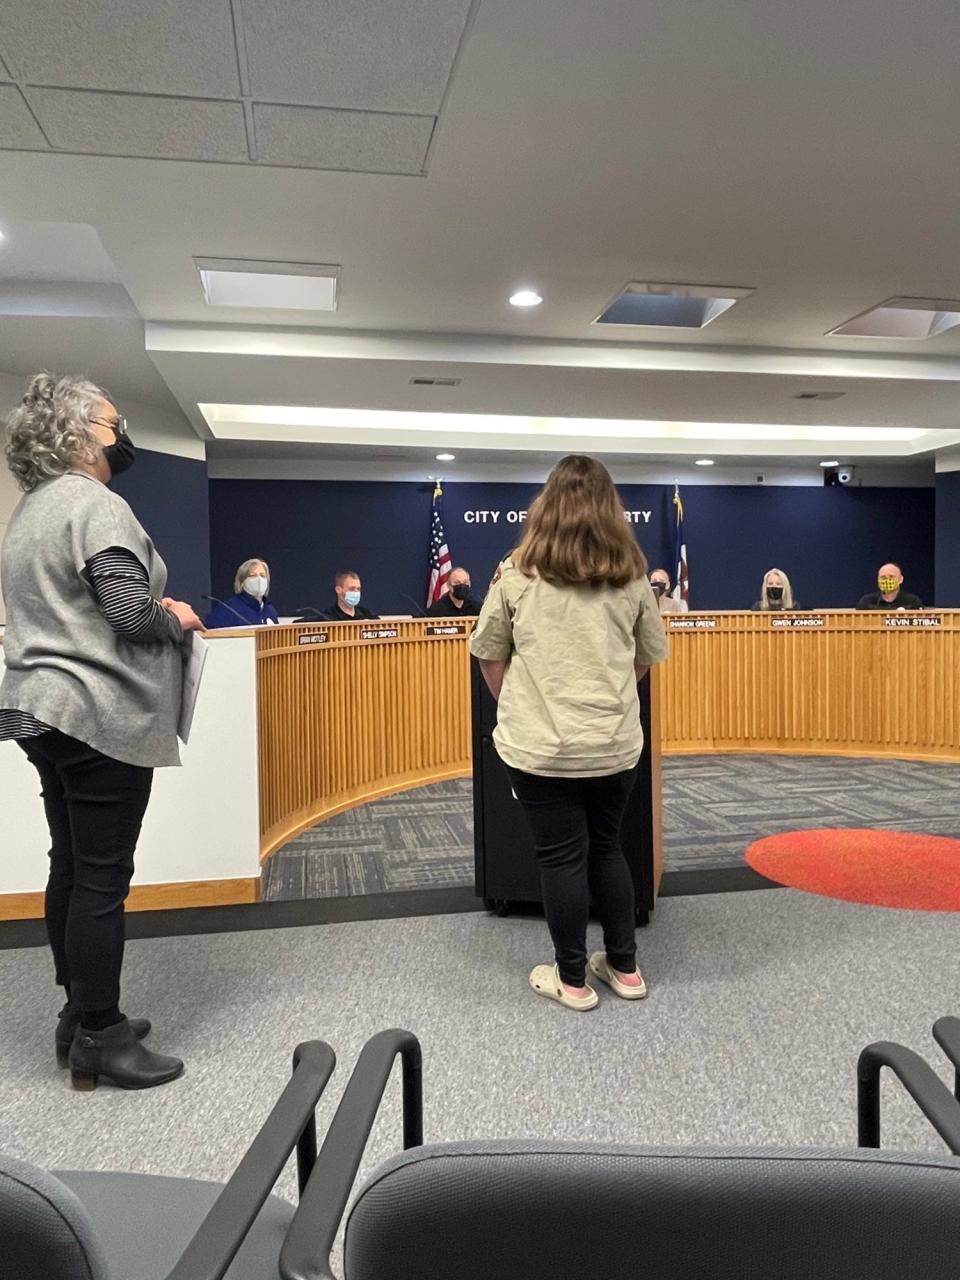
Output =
[{"x1": 0, "y1": 0, "x2": 470, "y2": 174}]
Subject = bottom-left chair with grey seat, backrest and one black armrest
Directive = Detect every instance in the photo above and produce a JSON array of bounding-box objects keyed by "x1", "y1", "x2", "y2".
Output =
[{"x1": 0, "y1": 1041, "x2": 337, "y2": 1280}]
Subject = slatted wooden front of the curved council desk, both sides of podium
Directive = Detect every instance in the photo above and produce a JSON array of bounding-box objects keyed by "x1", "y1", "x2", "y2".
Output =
[{"x1": 256, "y1": 611, "x2": 960, "y2": 858}]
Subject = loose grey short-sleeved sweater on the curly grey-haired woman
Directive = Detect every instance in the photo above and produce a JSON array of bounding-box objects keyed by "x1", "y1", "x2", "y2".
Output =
[{"x1": 0, "y1": 472, "x2": 182, "y2": 768}]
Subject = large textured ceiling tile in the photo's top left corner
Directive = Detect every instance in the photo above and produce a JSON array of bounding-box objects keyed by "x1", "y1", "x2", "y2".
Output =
[{"x1": 0, "y1": 0, "x2": 239, "y2": 97}]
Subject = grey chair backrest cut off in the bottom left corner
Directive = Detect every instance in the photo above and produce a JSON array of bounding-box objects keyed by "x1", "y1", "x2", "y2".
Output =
[{"x1": 0, "y1": 1156, "x2": 108, "y2": 1280}]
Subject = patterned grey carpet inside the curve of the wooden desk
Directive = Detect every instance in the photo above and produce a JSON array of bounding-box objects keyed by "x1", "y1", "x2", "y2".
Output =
[{"x1": 262, "y1": 755, "x2": 960, "y2": 901}]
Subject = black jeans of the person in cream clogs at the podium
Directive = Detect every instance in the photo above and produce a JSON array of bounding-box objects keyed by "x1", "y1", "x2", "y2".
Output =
[{"x1": 507, "y1": 767, "x2": 636, "y2": 987}]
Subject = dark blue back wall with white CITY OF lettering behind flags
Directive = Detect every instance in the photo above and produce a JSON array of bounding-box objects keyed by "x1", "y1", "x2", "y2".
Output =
[{"x1": 210, "y1": 480, "x2": 934, "y2": 613}]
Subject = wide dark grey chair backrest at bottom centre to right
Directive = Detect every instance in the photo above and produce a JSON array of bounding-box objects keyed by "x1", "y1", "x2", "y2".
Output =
[{"x1": 344, "y1": 1142, "x2": 960, "y2": 1280}]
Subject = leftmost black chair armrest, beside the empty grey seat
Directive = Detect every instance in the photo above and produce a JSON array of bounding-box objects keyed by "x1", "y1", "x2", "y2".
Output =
[{"x1": 161, "y1": 1041, "x2": 337, "y2": 1280}]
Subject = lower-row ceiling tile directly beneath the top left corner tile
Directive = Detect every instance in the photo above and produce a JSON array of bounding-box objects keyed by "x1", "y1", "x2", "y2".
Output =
[{"x1": 27, "y1": 88, "x2": 247, "y2": 161}]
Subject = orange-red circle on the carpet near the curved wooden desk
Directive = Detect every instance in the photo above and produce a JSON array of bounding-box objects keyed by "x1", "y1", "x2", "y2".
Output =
[{"x1": 744, "y1": 828, "x2": 960, "y2": 911}]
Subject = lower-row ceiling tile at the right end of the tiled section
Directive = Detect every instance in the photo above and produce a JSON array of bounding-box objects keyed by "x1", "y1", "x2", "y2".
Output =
[{"x1": 253, "y1": 102, "x2": 435, "y2": 174}]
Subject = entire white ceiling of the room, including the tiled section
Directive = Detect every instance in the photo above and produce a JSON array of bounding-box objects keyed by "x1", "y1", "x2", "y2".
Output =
[{"x1": 0, "y1": 0, "x2": 960, "y2": 471}]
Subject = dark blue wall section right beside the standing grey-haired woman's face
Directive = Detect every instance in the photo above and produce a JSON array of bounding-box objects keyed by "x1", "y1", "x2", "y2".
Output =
[{"x1": 111, "y1": 449, "x2": 210, "y2": 614}]
